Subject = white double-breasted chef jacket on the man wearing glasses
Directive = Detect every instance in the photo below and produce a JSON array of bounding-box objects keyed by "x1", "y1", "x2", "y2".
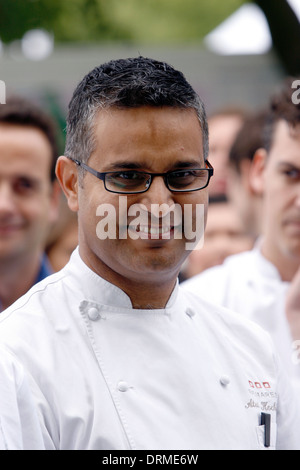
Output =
[{"x1": 0, "y1": 250, "x2": 300, "y2": 450}]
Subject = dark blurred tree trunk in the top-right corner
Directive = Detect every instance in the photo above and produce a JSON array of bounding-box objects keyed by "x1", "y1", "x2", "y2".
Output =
[{"x1": 254, "y1": 0, "x2": 300, "y2": 76}]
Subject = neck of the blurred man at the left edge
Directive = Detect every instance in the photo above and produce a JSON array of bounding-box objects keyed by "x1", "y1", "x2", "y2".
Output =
[{"x1": 0, "y1": 253, "x2": 41, "y2": 310}]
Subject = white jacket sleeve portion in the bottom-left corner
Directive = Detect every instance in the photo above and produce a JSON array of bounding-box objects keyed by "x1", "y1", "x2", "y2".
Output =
[{"x1": 0, "y1": 348, "x2": 44, "y2": 450}]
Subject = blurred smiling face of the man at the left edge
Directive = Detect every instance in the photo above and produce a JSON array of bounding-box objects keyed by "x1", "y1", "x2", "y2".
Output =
[{"x1": 0, "y1": 124, "x2": 54, "y2": 262}]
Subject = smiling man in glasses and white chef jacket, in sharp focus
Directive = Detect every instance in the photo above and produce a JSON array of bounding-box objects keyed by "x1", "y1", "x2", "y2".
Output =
[{"x1": 0, "y1": 57, "x2": 300, "y2": 450}]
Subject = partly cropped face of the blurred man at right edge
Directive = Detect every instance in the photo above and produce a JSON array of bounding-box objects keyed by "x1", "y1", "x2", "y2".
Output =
[{"x1": 264, "y1": 121, "x2": 300, "y2": 264}]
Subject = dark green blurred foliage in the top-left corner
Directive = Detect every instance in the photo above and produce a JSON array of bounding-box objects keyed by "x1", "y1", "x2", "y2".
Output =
[{"x1": 0, "y1": 0, "x2": 131, "y2": 43}]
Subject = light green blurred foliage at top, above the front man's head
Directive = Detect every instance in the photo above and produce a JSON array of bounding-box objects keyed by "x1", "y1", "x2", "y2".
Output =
[{"x1": 106, "y1": 0, "x2": 247, "y2": 44}]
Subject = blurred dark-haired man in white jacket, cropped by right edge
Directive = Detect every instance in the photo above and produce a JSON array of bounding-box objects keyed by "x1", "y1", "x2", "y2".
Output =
[{"x1": 184, "y1": 78, "x2": 300, "y2": 390}]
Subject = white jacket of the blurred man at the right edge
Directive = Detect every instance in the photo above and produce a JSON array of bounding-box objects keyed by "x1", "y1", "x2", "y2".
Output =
[{"x1": 182, "y1": 241, "x2": 300, "y2": 390}]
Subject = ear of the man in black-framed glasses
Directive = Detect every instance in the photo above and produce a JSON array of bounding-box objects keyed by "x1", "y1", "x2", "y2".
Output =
[{"x1": 56, "y1": 156, "x2": 79, "y2": 212}]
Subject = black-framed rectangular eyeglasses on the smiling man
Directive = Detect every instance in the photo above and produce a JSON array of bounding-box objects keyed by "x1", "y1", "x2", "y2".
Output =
[{"x1": 69, "y1": 157, "x2": 214, "y2": 194}]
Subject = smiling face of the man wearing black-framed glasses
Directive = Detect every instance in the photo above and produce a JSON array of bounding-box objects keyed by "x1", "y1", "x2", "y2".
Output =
[{"x1": 78, "y1": 107, "x2": 208, "y2": 282}]
